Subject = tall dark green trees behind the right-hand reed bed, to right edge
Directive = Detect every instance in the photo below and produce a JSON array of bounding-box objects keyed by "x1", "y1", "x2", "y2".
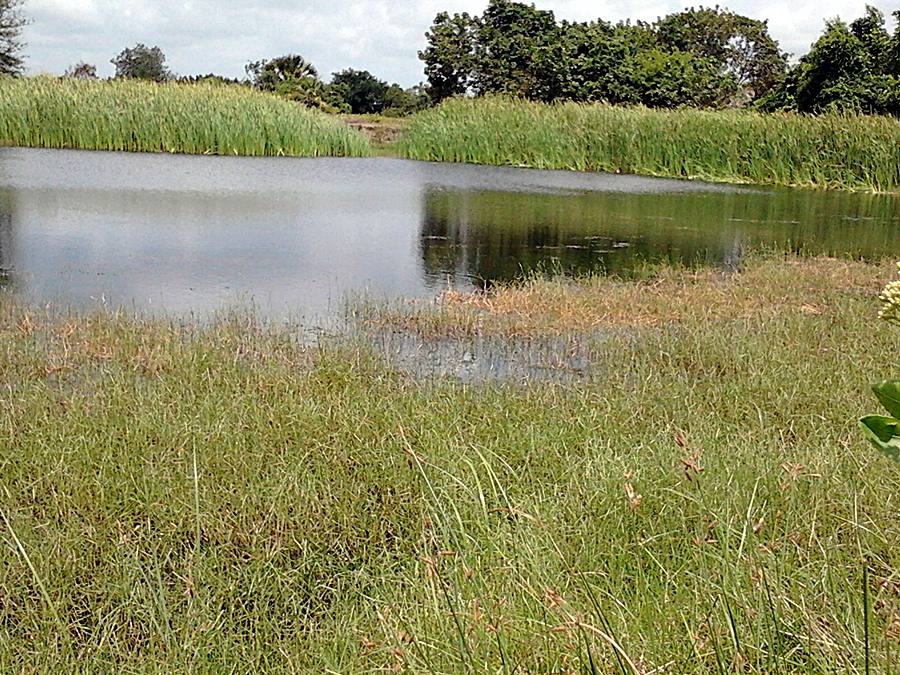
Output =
[{"x1": 419, "y1": 0, "x2": 900, "y2": 115}]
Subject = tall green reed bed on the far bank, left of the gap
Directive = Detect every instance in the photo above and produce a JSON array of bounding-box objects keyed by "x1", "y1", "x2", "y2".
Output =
[{"x1": 0, "y1": 78, "x2": 370, "y2": 157}]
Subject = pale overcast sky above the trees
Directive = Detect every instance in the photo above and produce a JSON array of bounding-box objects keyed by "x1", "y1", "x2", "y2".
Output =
[{"x1": 24, "y1": 0, "x2": 897, "y2": 86}]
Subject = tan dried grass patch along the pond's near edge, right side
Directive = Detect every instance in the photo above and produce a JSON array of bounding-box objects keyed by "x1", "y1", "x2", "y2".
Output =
[{"x1": 366, "y1": 257, "x2": 893, "y2": 338}]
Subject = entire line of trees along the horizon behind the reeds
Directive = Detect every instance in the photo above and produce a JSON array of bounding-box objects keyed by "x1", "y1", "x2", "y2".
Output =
[{"x1": 0, "y1": 0, "x2": 900, "y2": 116}]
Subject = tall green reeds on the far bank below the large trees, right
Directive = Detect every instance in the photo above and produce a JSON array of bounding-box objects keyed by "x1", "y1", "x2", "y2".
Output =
[{"x1": 398, "y1": 99, "x2": 900, "y2": 192}]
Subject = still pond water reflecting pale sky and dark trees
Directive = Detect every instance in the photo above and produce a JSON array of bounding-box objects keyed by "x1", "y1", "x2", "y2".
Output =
[{"x1": 0, "y1": 149, "x2": 900, "y2": 319}]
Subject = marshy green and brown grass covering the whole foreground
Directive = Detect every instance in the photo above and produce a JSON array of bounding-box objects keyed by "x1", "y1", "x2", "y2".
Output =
[{"x1": 0, "y1": 260, "x2": 900, "y2": 675}]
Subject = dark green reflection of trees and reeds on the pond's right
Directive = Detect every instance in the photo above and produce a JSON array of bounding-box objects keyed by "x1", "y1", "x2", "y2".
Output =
[{"x1": 420, "y1": 190, "x2": 900, "y2": 286}]
